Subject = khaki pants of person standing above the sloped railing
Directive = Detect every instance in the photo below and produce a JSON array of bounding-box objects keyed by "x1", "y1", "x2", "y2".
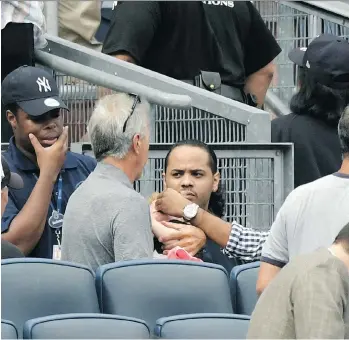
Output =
[{"x1": 58, "y1": 0, "x2": 102, "y2": 51}]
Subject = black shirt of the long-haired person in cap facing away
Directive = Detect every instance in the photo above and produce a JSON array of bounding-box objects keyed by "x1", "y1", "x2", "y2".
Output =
[{"x1": 271, "y1": 114, "x2": 342, "y2": 187}]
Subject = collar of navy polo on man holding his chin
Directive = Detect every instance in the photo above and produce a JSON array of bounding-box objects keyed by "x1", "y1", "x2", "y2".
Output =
[{"x1": 7, "y1": 137, "x2": 78, "y2": 171}]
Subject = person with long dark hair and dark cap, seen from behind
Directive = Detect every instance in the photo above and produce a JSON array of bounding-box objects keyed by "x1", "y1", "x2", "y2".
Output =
[{"x1": 271, "y1": 34, "x2": 349, "y2": 187}]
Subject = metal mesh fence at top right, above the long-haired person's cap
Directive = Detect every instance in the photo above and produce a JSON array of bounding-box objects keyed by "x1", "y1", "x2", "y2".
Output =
[{"x1": 254, "y1": 1, "x2": 349, "y2": 103}]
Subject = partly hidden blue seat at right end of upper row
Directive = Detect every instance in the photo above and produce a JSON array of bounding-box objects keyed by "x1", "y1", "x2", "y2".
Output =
[{"x1": 230, "y1": 262, "x2": 260, "y2": 315}]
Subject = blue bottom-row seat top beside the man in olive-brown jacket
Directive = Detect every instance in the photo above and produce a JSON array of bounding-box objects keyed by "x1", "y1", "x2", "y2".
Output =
[{"x1": 155, "y1": 314, "x2": 250, "y2": 339}]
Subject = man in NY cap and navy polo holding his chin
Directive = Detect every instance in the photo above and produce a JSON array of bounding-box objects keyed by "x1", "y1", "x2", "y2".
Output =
[{"x1": 1, "y1": 66, "x2": 96, "y2": 259}]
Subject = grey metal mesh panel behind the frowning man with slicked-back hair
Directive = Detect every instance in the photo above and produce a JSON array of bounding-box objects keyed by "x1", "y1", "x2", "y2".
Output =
[{"x1": 72, "y1": 143, "x2": 293, "y2": 230}]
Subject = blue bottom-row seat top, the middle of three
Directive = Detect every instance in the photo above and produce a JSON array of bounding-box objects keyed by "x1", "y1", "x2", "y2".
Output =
[{"x1": 23, "y1": 314, "x2": 150, "y2": 339}]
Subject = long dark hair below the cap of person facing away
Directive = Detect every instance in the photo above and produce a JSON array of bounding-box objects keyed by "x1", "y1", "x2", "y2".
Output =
[{"x1": 290, "y1": 67, "x2": 349, "y2": 126}]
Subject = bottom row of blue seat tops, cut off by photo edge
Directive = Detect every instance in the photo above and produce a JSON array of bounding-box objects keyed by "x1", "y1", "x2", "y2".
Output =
[{"x1": 1, "y1": 314, "x2": 249, "y2": 339}]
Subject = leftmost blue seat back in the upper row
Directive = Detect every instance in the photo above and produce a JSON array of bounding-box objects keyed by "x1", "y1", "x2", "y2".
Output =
[{"x1": 1, "y1": 258, "x2": 99, "y2": 337}]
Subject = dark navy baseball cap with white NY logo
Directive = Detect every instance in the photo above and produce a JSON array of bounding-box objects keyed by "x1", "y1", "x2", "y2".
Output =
[{"x1": 1, "y1": 66, "x2": 69, "y2": 116}]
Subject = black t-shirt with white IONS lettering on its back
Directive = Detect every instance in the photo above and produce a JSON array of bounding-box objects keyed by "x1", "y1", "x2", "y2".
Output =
[{"x1": 103, "y1": 1, "x2": 281, "y2": 86}]
